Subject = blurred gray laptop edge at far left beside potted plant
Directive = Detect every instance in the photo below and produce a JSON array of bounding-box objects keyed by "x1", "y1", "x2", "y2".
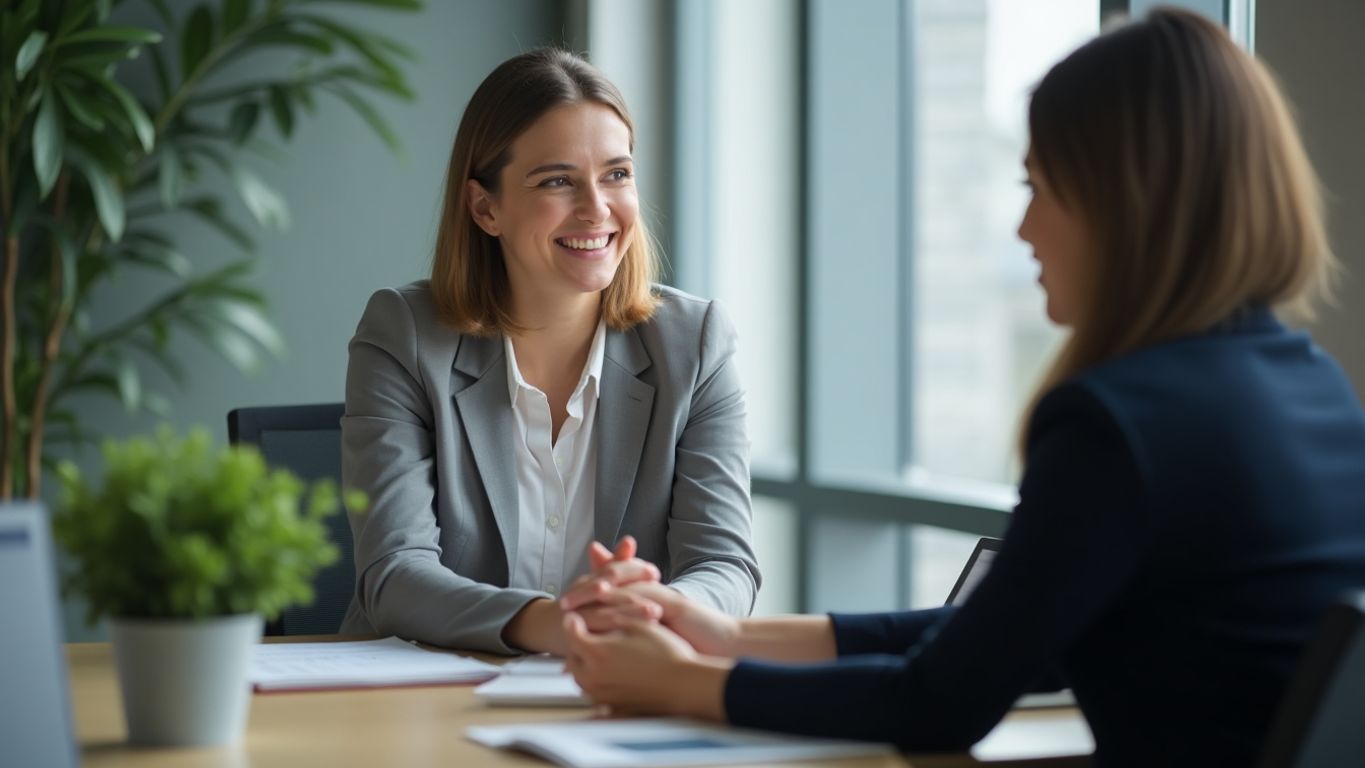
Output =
[{"x1": 0, "y1": 503, "x2": 79, "y2": 768}]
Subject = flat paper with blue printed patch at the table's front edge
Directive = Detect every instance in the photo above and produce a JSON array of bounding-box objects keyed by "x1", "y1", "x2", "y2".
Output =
[{"x1": 465, "y1": 719, "x2": 893, "y2": 768}]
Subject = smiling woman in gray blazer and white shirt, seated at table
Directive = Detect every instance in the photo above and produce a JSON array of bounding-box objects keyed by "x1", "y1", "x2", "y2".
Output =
[{"x1": 331, "y1": 49, "x2": 759, "y2": 653}]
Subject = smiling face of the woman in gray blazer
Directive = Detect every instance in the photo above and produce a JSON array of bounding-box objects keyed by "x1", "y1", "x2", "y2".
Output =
[{"x1": 468, "y1": 102, "x2": 640, "y2": 301}]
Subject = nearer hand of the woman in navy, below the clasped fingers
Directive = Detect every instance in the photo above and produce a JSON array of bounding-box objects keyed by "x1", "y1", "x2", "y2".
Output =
[{"x1": 564, "y1": 612, "x2": 732, "y2": 720}]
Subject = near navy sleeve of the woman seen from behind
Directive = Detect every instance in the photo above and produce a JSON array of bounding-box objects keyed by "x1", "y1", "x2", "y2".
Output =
[{"x1": 725, "y1": 386, "x2": 1148, "y2": 752}]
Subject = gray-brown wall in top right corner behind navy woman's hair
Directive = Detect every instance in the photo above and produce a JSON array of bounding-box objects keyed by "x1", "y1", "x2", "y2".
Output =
[{"x1": 1256, "y1": 0, "x2": 1365, "y2": 397}]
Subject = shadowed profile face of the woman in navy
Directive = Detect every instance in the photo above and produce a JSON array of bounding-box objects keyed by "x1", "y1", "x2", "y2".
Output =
[{"x1": 1018, "y1": 153, "x2": 1088, "y2": 326}]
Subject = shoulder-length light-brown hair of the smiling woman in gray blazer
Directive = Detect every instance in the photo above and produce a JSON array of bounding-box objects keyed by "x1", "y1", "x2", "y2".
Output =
[{"x1": 431, "y1": 48, "x2": 658, "y2": 336}]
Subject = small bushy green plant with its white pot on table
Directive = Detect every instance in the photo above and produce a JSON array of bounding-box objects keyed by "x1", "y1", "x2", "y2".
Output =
[{"x1": 53, "y1": 427, "x2": 364, "y2": 745}]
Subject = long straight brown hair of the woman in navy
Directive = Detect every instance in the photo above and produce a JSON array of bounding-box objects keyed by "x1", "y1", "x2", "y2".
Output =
[{"x1": 1024, "y1": 8, "x2": 1335, "y2": 447}]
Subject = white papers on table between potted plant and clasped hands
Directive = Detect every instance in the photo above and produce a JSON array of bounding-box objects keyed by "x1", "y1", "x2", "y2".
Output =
[{"x1": 250, "y1": 637, "x2": 498, "y2": 690}]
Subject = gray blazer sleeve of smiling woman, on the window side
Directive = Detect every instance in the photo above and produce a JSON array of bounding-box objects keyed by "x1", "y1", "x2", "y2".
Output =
[{"x1": 667, "y1": 301, "x2": 762, "y2": 617}]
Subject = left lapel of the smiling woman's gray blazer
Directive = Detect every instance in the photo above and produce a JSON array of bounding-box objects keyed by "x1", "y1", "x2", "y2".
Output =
[{"x1": 455, "y1": 336, "x2": 520, "y2": 573}]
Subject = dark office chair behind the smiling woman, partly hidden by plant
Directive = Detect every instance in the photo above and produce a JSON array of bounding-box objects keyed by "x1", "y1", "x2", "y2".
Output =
[{"x1": 228, "y1": 402, "x2": 355, "y2": 634}]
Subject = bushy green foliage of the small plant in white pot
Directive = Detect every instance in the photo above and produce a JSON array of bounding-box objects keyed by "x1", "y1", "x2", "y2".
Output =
[{"x1": 53, "y1": 427, "x2": 366, "y2": 623}]
